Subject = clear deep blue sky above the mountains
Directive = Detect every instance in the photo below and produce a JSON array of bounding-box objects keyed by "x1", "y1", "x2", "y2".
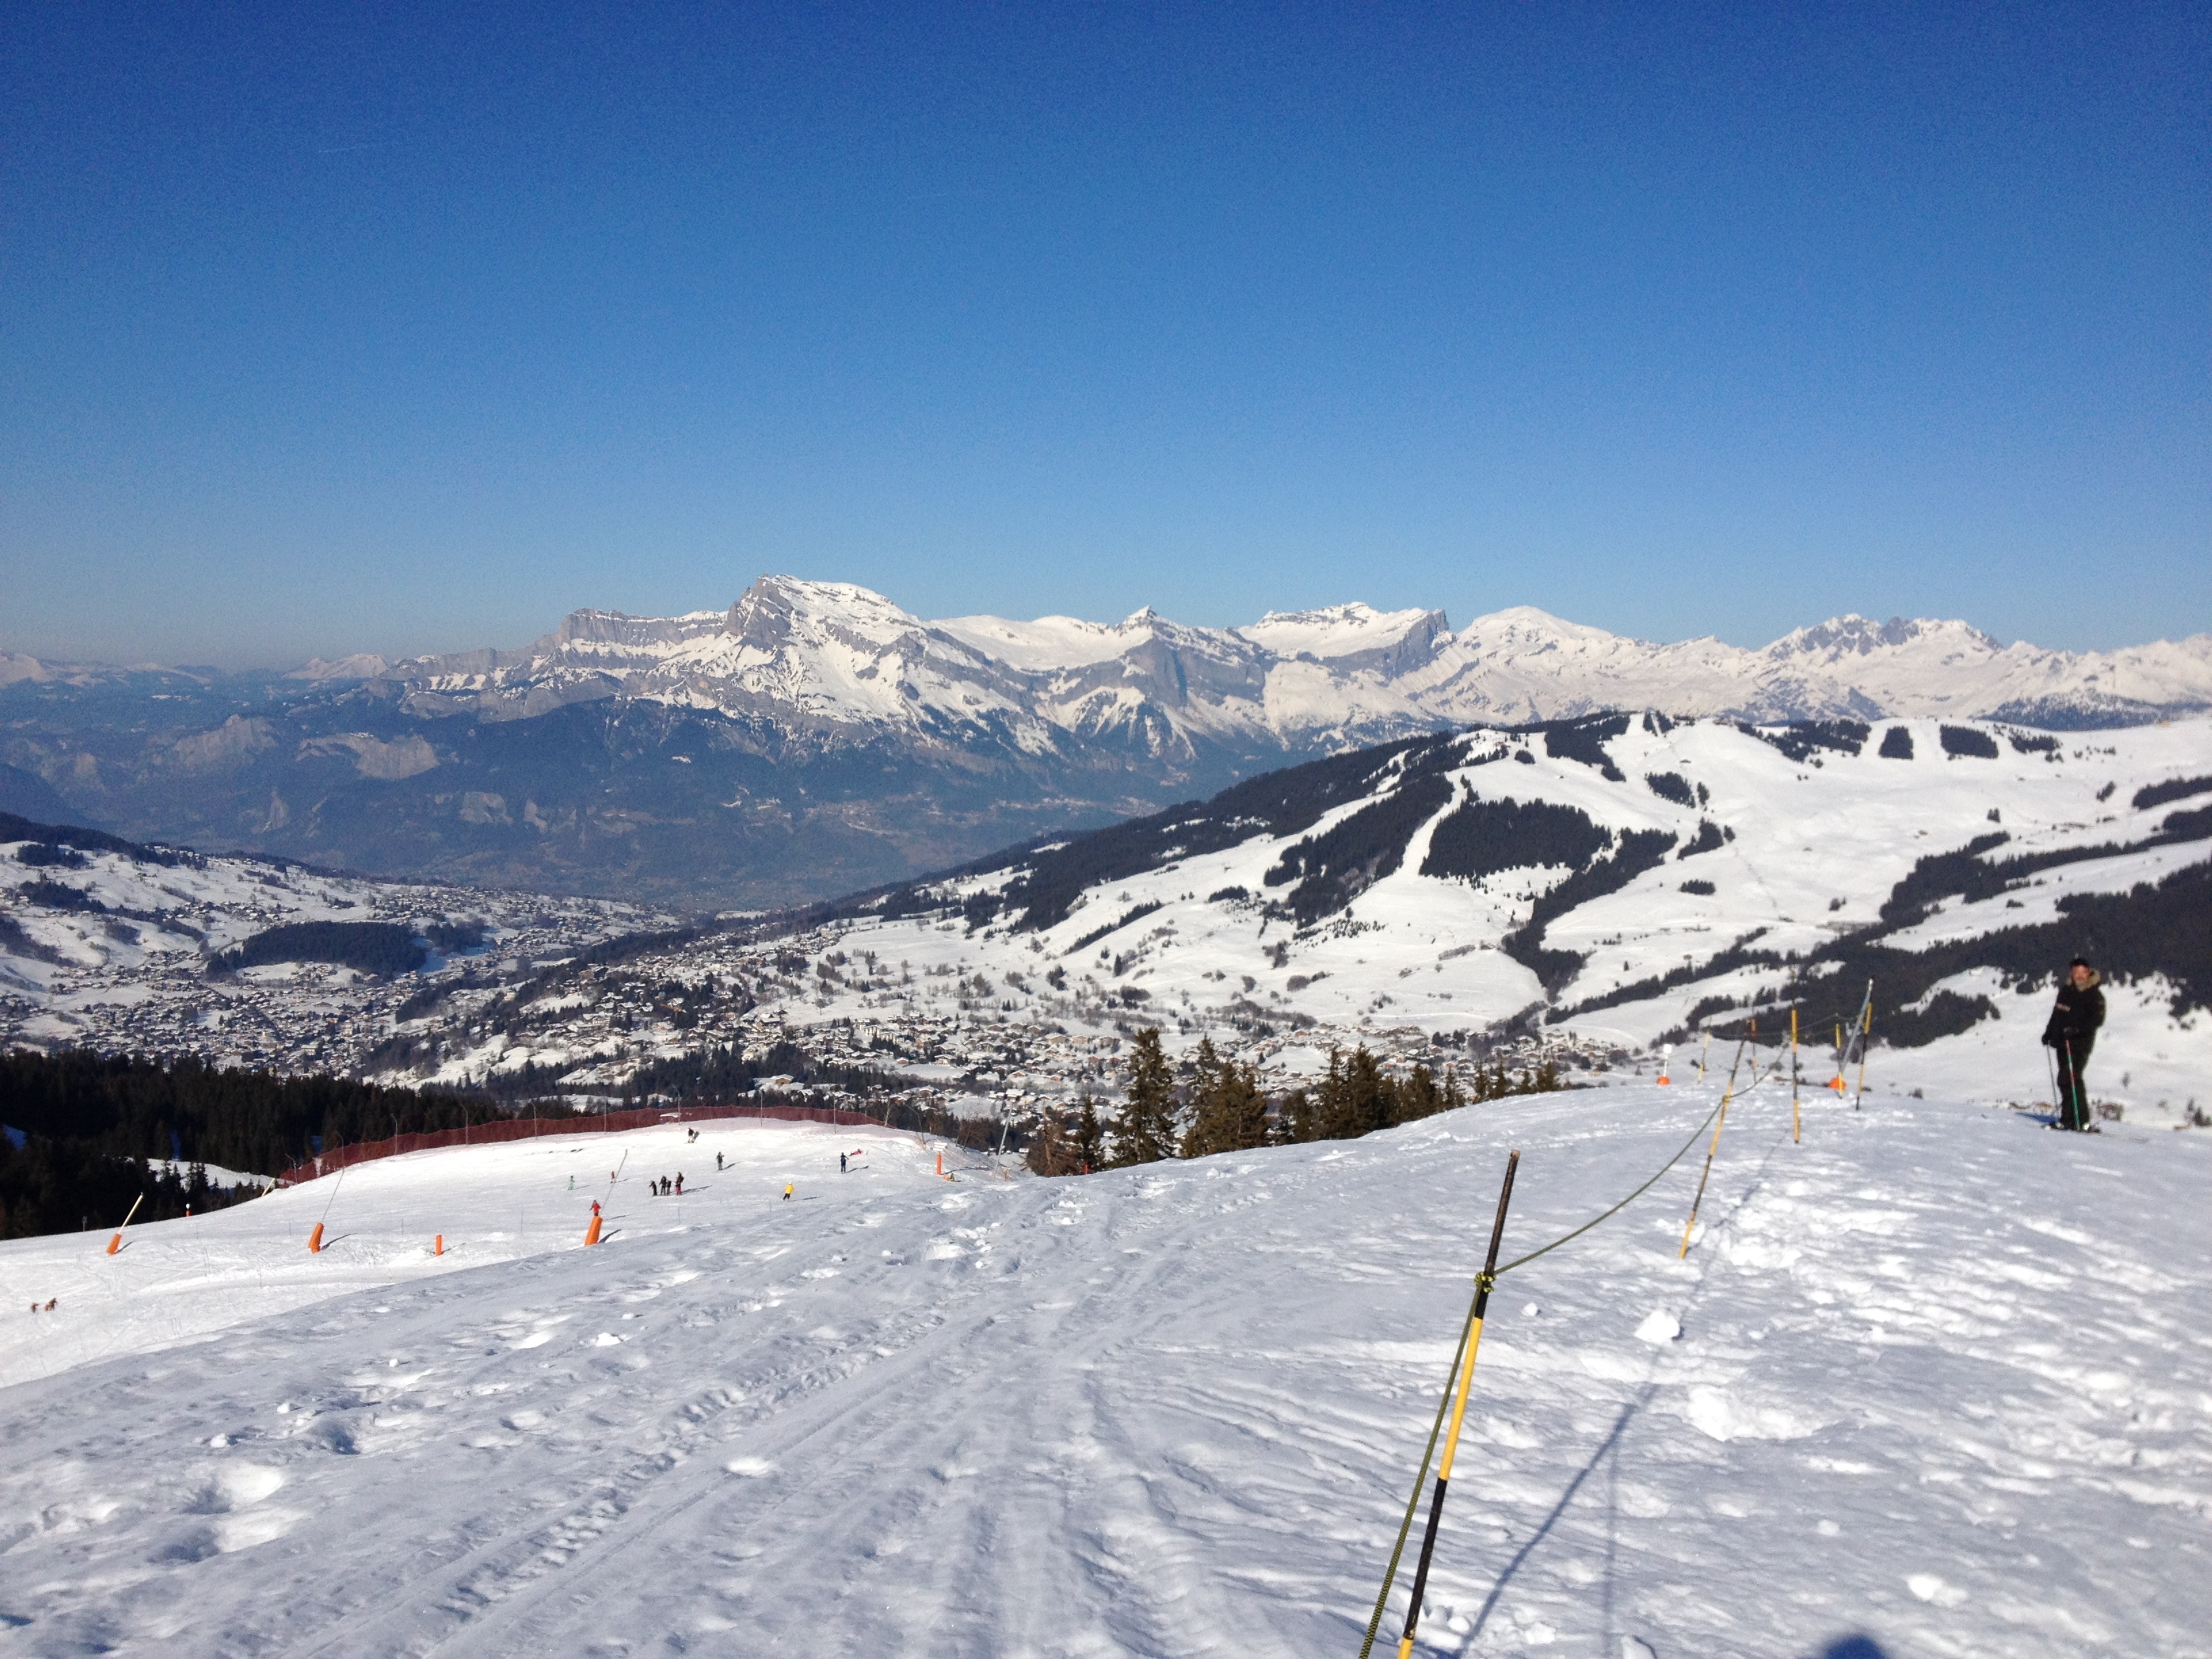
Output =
[{"x1": 0, "y1": 5, "x2": 2212, "y2": 663}]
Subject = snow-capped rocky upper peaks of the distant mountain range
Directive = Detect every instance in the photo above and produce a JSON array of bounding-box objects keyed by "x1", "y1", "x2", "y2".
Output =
[{"x1": 296, "y1": 575, "x2": 2212, "y2": 754}]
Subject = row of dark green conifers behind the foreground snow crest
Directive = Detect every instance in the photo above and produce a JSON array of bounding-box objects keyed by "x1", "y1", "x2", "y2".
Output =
[{"x1": 1029, "y1": 1029, "x2": 1564, "y2": 1174}]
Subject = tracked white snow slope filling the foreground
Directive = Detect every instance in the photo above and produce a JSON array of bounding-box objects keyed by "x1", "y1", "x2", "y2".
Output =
[{"x1": 0, "y1": 1084, "x2": 2212, "y2": 1659}]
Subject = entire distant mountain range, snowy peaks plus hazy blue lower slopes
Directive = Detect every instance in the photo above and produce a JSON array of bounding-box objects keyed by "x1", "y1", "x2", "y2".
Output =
[{"x1": 0, "y1": 575, "x2": 2212, "y2": 907}]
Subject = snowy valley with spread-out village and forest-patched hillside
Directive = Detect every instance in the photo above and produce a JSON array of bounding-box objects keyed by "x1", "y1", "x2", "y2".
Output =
[{"x1": 0, "y1": 717, "x2": 2212, "y2": 1124}]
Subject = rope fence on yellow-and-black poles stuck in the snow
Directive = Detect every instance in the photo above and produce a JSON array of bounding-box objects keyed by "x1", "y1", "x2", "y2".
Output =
[{"x1": 1360, "y1": 1021, "x2": 1840, "y2": 1659}]
